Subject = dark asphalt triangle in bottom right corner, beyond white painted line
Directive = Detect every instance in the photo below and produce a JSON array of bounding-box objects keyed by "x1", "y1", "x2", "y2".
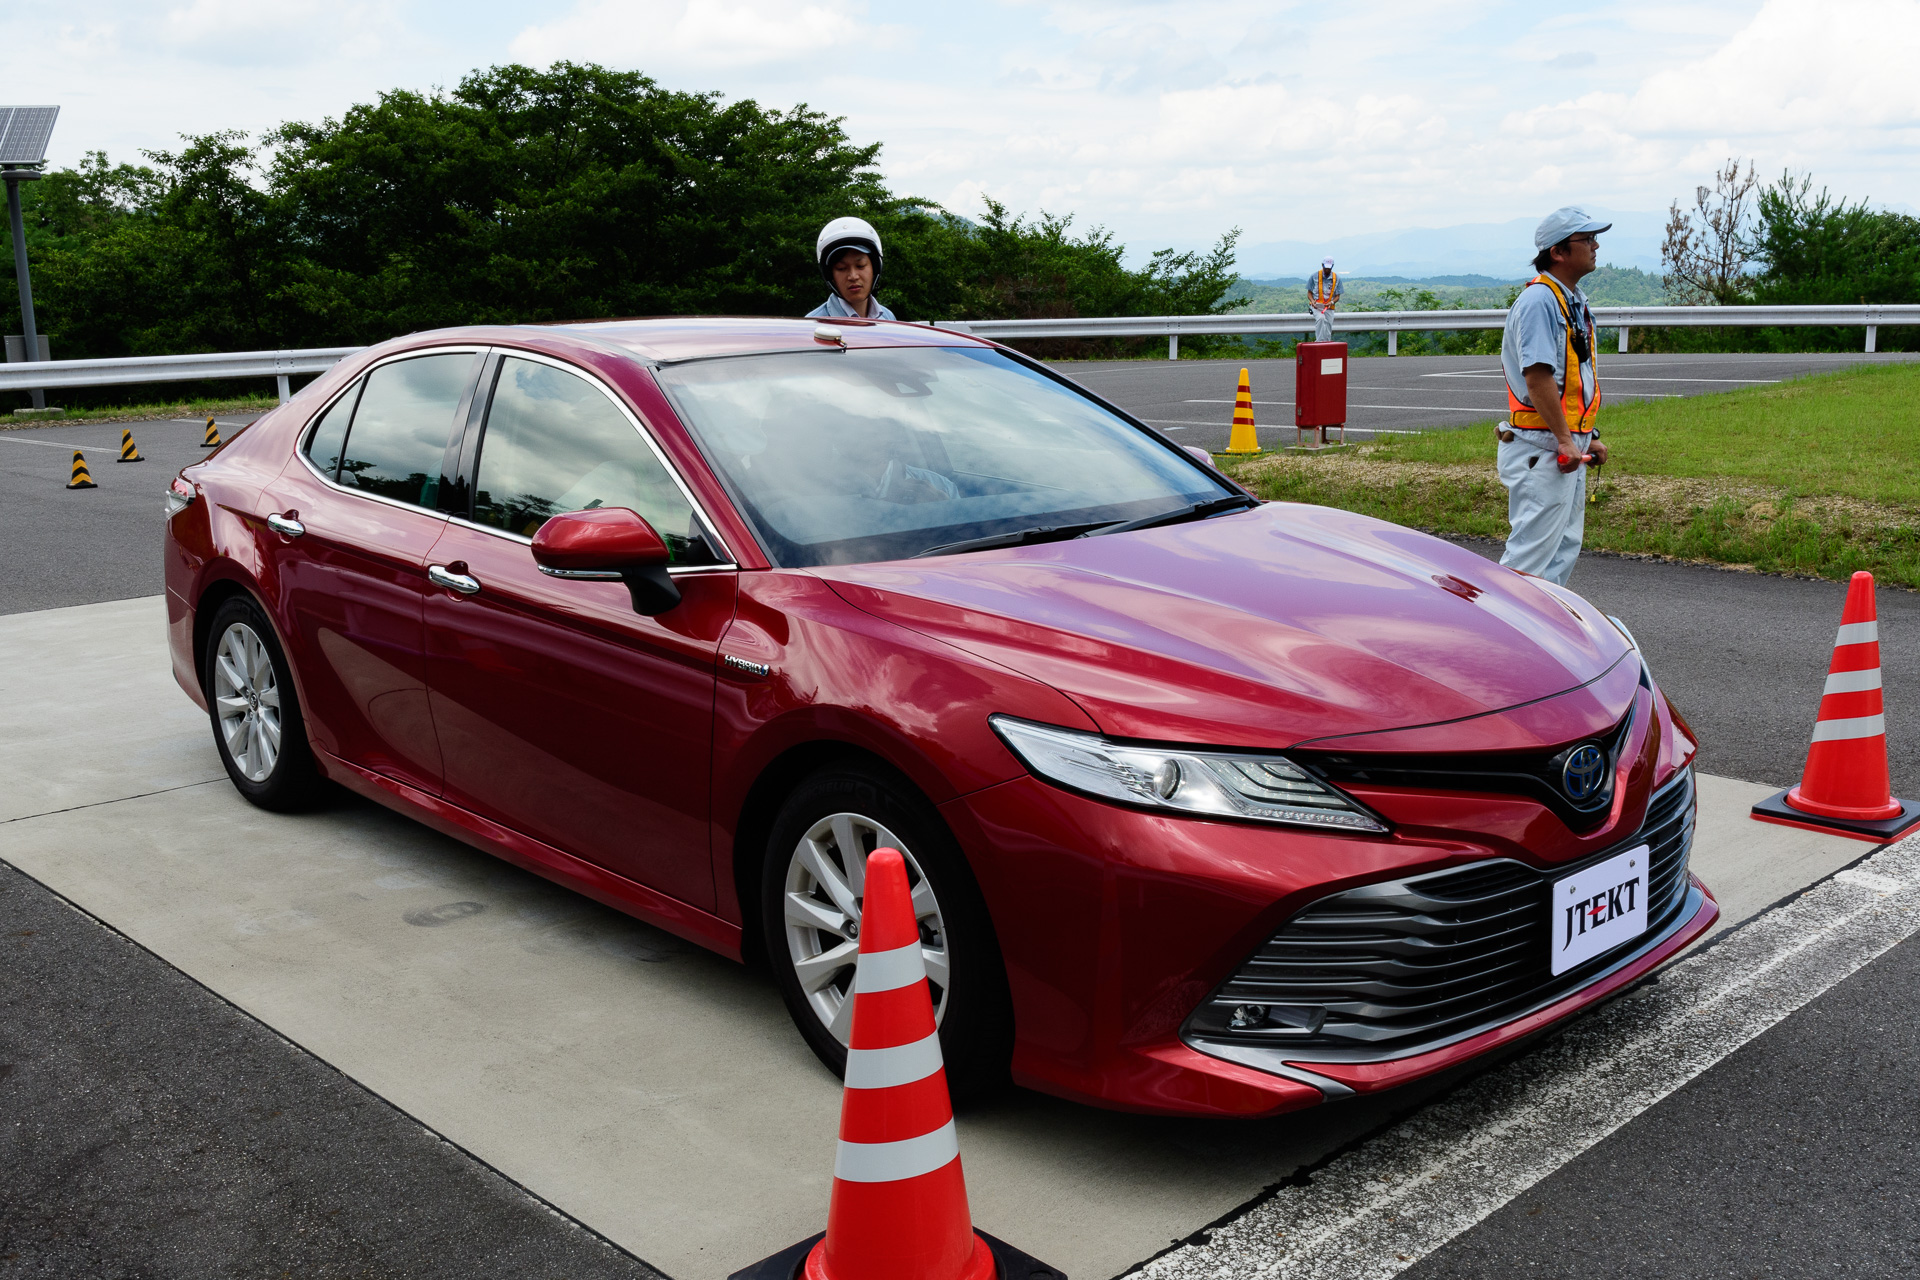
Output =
[{"x1": 1402, "y1": 924, "x2": 1920, "y2": 1280}]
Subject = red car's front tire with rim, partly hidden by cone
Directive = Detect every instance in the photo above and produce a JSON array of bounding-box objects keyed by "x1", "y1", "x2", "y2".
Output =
[{"x1": 760, "y1": 764, "x2": 1014, "y2": 1098}]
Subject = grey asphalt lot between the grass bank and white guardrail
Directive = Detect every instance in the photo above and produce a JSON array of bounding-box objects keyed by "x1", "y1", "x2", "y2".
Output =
[{"x1": 1054, "y1": 351, "x2": 1914, "y2": 453}]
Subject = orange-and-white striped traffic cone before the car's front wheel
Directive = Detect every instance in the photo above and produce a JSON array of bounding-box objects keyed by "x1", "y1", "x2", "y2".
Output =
[{"x1": 730, "y1": 848, "x2": 1066, "y2": 1280}]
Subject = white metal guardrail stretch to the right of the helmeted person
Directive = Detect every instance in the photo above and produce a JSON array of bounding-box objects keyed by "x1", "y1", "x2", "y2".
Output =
[{"x1": 941, "y1": 305, "x2": 1920, "y2": 359}]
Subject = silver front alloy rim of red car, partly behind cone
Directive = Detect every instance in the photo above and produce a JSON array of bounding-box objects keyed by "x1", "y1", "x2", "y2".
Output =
[{"x1": 781, "y1": 814, "x2": 950, "y2": 1044}]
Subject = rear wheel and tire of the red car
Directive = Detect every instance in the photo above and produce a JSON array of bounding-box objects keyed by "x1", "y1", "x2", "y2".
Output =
[{"x1": 202, "y1": 595, "x2": 324, "y2": 814}]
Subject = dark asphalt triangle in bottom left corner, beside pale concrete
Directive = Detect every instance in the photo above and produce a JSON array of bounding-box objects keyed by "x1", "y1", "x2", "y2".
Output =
[{"x1": 0, "y1": 864, "x2": 659, "y2": 1280}]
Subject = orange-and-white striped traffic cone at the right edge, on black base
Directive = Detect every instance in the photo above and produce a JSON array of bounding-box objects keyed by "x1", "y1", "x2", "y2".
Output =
[{"x1": 1753, "y1": 572, "x2": 1920, "y2": 844}]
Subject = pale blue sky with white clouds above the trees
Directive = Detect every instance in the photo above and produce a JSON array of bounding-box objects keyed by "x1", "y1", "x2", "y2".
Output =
[{"x1": 0, "y1": 0, "x2": 1920, "y2": 268}]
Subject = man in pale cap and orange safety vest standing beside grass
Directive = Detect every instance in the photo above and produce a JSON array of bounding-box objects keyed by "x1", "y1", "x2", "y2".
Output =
[{"x1": 1500, "y1": 205, "x2": 1613, "y2": 587}]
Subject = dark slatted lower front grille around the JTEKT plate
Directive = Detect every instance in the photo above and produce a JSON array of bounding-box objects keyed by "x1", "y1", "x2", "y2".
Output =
[{"x1": 1183, "y1": 770, "x2": 1695, "y2": 1065}]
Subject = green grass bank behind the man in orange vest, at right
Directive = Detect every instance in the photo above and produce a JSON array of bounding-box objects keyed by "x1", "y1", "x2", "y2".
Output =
[{"x1": 1227, "y1": 365, "x2": 1920, "y2": 587}]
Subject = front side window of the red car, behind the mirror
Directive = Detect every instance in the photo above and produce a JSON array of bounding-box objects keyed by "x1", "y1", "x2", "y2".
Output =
[{"x1": 474, "y1": 357, "x2": 720, "y2": 564}]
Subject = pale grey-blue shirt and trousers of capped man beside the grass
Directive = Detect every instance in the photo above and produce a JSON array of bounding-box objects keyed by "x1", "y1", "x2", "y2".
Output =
[{"x1": 1498, "y1": 284, "x2": 1599, "y2": 587}]
